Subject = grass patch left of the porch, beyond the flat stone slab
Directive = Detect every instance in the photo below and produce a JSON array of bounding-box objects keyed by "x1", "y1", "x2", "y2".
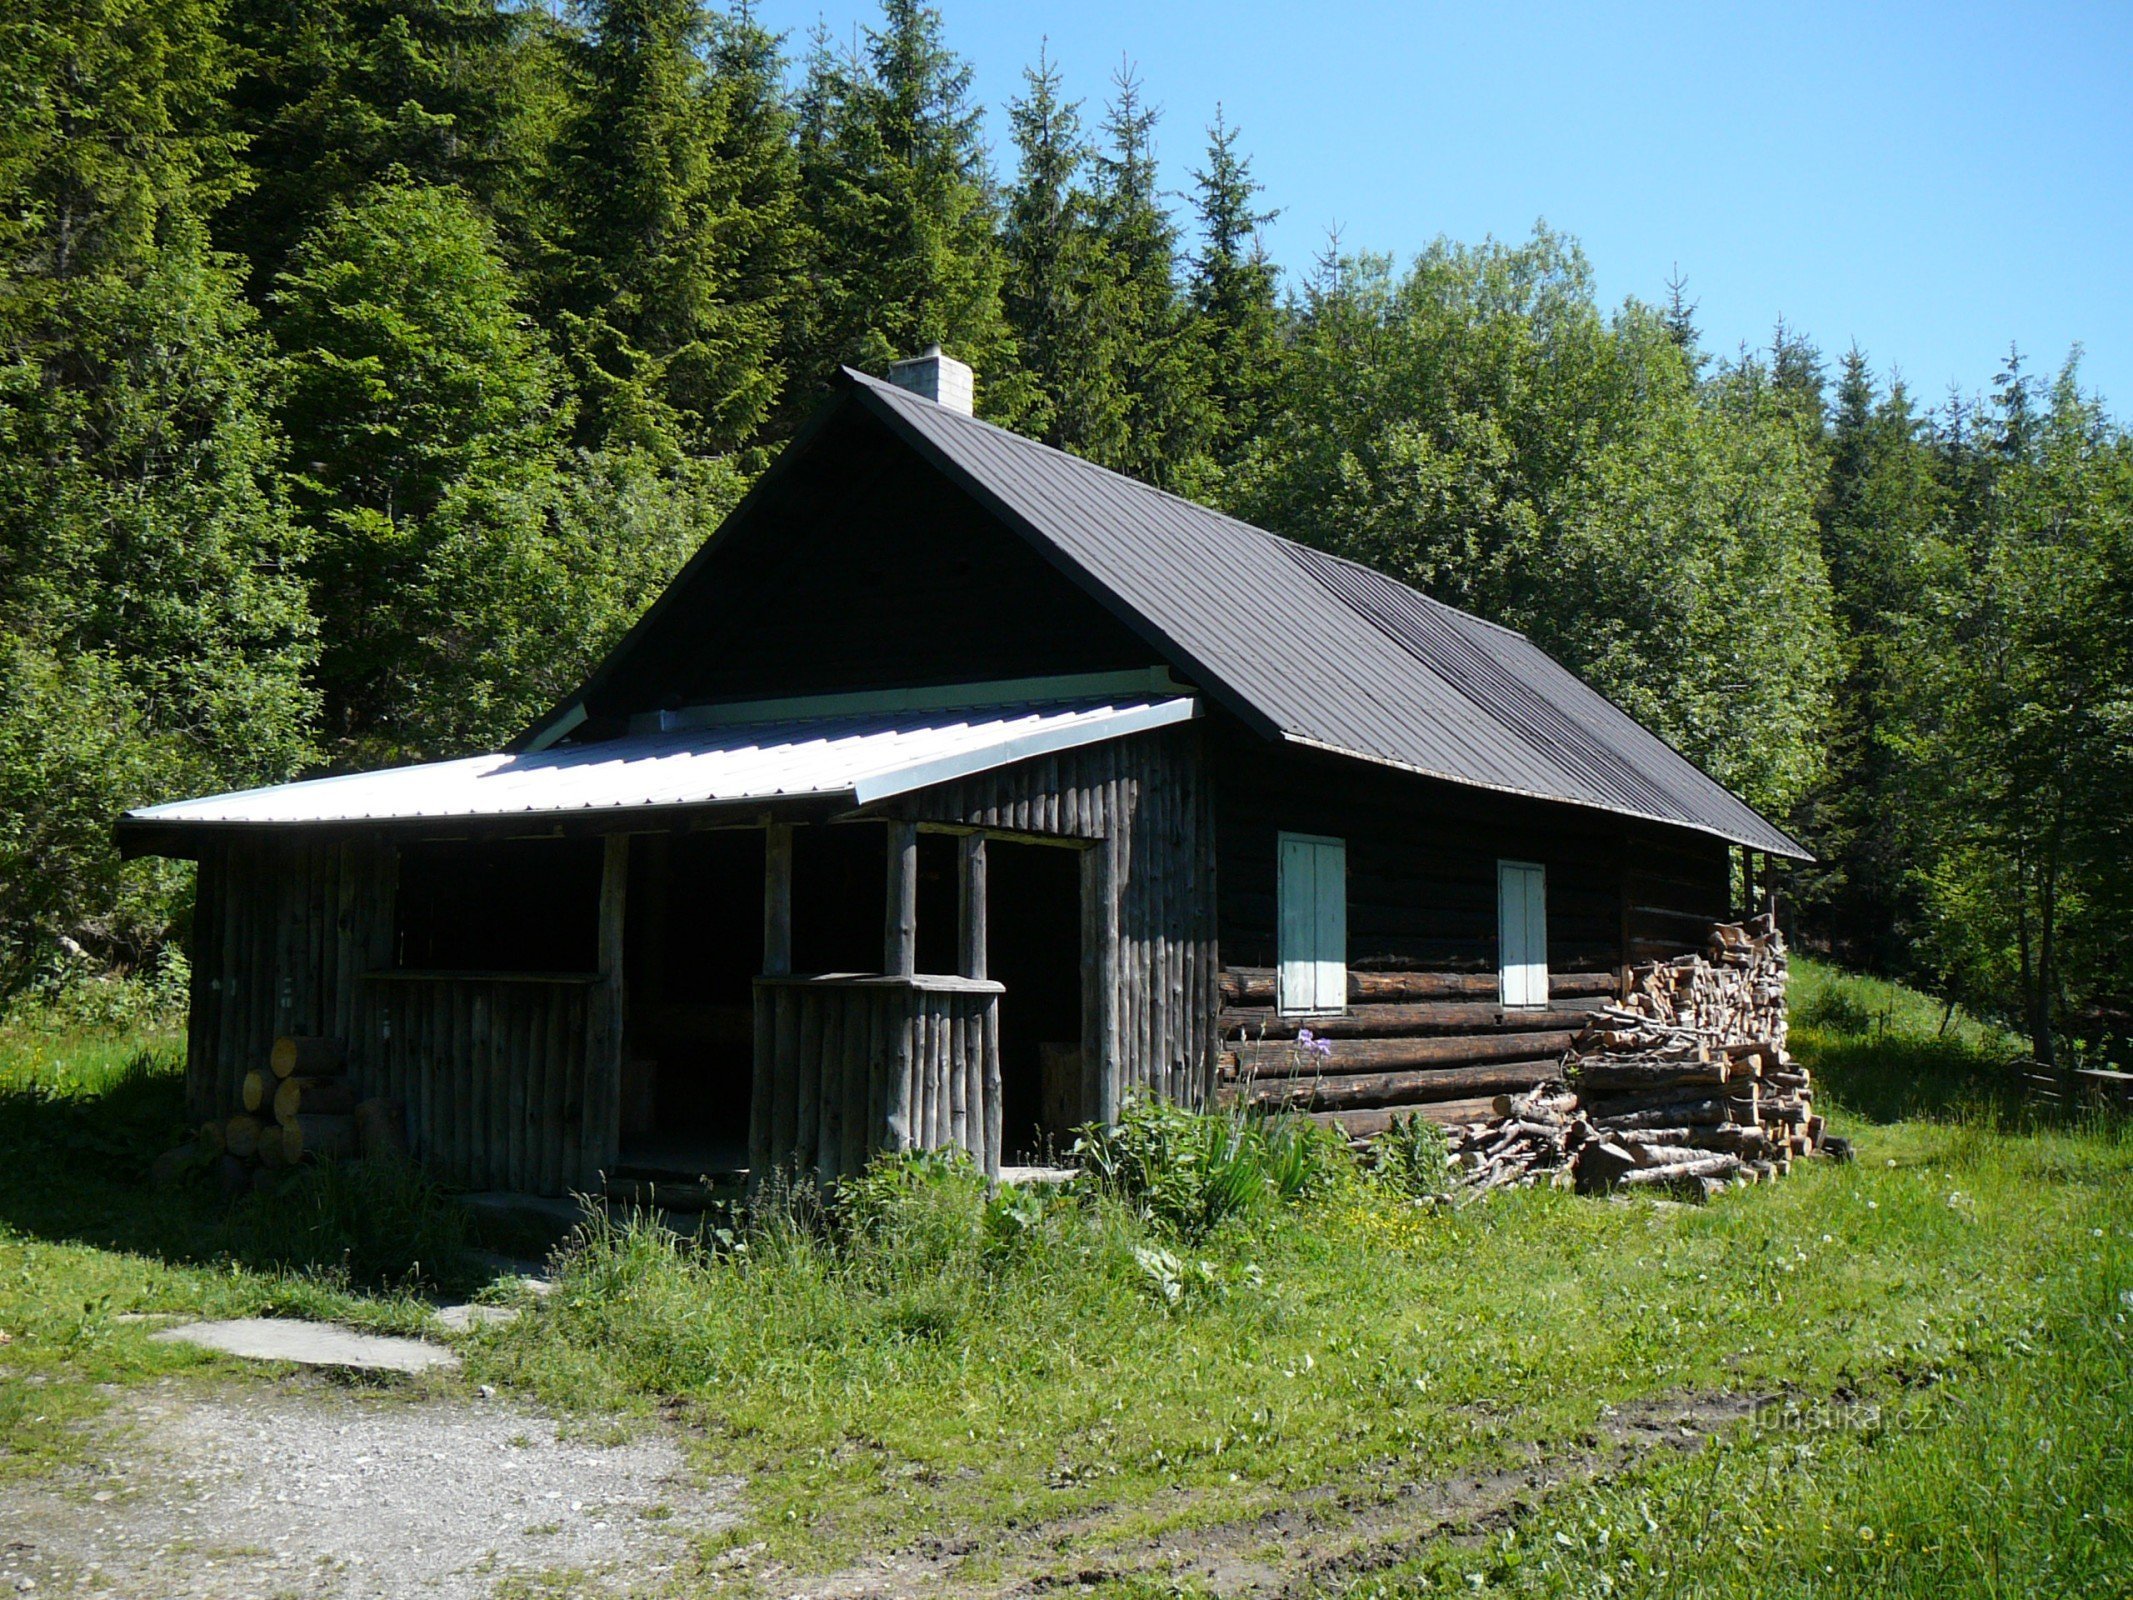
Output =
[{"x1": 0, "y1": 1022, "x2": 471, "y2": 1476}]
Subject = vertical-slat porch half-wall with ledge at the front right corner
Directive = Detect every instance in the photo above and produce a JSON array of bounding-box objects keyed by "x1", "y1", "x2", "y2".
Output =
[{"x1": 749, "y1": 973, "x2": 1003, "y2": 1186}]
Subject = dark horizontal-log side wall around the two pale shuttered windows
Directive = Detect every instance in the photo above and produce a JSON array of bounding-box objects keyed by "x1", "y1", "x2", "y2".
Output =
[{"x1": 1209, "y1": 732, "x2": 1730, "y2": 1133}]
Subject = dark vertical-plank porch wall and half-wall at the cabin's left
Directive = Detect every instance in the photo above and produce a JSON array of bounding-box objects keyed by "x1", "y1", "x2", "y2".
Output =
[{"x1": 186, "y1": 834, "x2": 621, "y2": 1195}]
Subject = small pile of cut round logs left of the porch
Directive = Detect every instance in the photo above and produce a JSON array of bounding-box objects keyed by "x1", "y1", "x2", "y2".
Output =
[{"x1": 151, "y1": 1037, "x2": 407, "y2": 1193}]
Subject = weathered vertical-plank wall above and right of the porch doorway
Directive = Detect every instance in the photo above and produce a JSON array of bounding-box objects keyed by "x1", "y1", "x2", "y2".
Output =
[{"x1": 894, "y1": 725, "x2": 1220, "y2": 1116}]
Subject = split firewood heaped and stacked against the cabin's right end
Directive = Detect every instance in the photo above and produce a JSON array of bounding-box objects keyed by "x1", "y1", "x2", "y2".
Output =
[{"x1": 1446, "y1": 919, "x2": 1822, "y2": 1195}]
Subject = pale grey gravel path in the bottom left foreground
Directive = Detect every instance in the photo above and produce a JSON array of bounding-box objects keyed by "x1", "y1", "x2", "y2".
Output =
[{"x1": 0, "y1": 1385, "x2": 738, "y2": 1600}]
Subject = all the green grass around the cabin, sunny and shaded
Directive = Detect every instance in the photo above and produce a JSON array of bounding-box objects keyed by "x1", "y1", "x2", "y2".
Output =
[{"x1": 0, "y1": 964, "x2": 2133, "y2": 1596}]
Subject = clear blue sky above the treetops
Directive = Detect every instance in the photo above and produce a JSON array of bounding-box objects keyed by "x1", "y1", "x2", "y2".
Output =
[{"x1": 757, "y1": 0, "x2": 2133, "y2": 418}]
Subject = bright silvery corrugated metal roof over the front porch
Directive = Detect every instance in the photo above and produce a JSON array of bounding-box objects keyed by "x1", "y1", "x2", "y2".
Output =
[{"x1": 126, "y1": 695, "x2": 1197, "y2": 828}]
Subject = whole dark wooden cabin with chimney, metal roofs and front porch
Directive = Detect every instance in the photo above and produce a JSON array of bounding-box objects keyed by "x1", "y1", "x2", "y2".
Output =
[{"x1": 119, "y1": 352, "x2": 1802, "y2": 1195}]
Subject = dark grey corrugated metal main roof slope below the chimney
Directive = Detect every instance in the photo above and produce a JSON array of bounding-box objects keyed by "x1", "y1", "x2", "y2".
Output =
[{"x1": 847, "y1": 371, "x2": 1807, "y2": 858}]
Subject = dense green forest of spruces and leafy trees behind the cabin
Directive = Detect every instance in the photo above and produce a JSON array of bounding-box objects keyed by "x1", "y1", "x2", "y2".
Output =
[{"x1": 0, "y1": 0, "x2": 2133, "y2": 1060}]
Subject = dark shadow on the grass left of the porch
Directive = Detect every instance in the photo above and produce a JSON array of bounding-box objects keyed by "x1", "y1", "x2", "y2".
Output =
[{"x1": 0, "y1": 1050, "x2": 467, "y2": 1291}]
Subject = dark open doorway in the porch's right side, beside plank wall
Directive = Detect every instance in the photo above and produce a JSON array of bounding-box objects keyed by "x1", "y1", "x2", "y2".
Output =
[{"x1": 985, "y1": 838, "x2": 1094, "y2": 1165}]
